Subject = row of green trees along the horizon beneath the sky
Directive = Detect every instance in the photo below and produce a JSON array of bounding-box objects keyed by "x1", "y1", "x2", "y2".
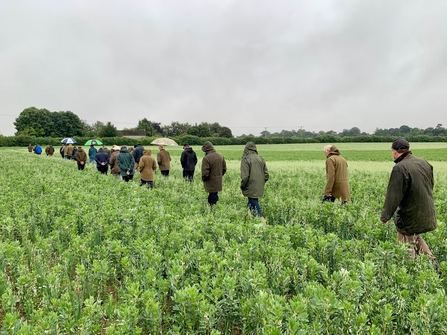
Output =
[{"x1": 7, "y1": 107, "x2": 447, "y2": 142}]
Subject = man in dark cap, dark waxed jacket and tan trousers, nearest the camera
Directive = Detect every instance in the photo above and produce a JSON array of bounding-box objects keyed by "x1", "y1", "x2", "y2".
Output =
[{"x1": 380, "y1": 138, "x2": 437, "y2": 264}]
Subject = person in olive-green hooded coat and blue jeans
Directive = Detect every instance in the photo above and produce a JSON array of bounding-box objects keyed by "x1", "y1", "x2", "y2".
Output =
[{"x1": 241, "y1": 142, "x2": 269, "y2": 223}]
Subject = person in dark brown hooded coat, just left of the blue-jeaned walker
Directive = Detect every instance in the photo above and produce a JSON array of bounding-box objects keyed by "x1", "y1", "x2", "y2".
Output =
[{"x1": 202, "y1": 141, "x2": 227, "y2": 207}]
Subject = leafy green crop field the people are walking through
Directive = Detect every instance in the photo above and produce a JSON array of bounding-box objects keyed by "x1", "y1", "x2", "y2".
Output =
[{"x1": 0, "y1": 143, "x2": 447, "y2": 335}]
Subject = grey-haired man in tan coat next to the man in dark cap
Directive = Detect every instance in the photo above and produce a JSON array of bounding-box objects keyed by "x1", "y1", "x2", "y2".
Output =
[{"x1": 322, "y1": 144, "x2": 351, "y2": 204}]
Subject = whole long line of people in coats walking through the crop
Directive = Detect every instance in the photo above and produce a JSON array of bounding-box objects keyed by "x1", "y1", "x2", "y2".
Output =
[{"x1": 28, "y1": 138, "x2": 438, "y2": 264}]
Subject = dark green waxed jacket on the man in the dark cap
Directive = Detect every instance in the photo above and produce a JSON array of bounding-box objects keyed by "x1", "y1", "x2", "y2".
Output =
[{"x1": 380, "y1": 151, "x2": 436, "y2": 235}]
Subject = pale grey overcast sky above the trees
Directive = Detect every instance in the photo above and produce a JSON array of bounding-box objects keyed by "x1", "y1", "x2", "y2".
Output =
[{"x1": 0, "y1": 0, "x2": 447, "y2": 136}]
